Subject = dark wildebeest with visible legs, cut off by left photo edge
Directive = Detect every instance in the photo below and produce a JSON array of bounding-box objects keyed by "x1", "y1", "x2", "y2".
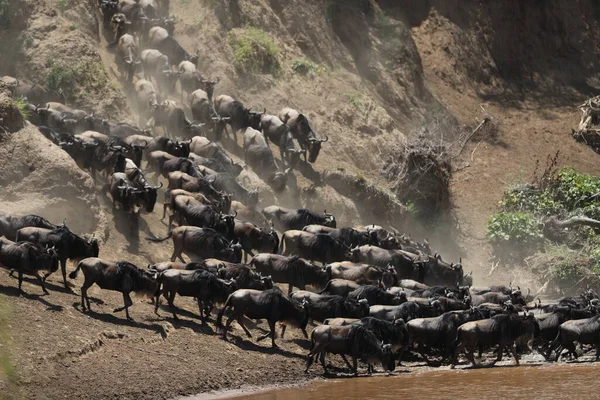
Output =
[{"x1": 0, "y1": 236, "x2": 58, "y2": 295}]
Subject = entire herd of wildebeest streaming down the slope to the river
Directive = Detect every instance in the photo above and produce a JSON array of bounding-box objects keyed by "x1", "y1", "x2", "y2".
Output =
[{"x1": 0, "y1": 0, "x2": 600, "y2": 374}]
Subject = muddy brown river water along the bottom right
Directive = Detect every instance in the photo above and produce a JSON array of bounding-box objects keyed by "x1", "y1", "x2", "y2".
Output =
[{"x1": 191, "y1": 363, "x2": 600, "y2": 400}]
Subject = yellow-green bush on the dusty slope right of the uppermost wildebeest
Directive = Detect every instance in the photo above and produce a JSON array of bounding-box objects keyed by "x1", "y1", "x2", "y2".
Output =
[{"x1": 229, "y1": 28, "x2": 281, "y2": 76}]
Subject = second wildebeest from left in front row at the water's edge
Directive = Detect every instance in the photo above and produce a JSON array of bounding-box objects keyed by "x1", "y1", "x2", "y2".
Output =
[{"x1": 407, "y1": 309, "x2": 483, "y2": 362}]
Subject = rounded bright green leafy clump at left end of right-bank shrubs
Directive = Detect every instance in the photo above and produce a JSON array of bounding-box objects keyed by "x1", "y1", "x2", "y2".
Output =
[{"x1": 487, "y1": 212, "x2": 543, "y2": 245}]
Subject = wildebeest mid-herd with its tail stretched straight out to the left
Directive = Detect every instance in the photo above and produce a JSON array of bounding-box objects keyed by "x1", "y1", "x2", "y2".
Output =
[{"x1": 146, "y1": 226, "x2": 242, "y2": 263}]
